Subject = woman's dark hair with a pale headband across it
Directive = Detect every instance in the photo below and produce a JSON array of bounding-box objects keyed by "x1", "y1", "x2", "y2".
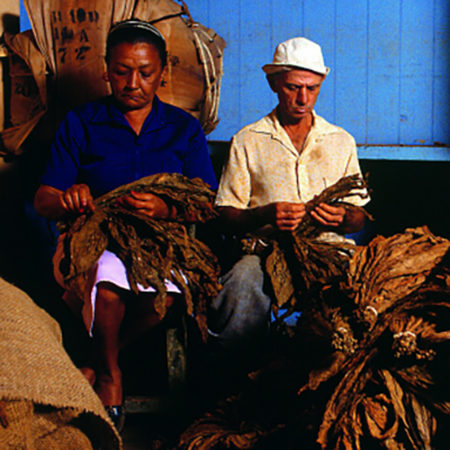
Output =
[{"x1": 105, "y1": 19, "x2": 167, "y2": 68}]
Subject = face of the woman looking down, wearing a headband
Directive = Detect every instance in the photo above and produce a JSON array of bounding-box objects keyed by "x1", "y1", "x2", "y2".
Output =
[{"x1": 107, "y1": 43, "x2": 165, "y2": 111}]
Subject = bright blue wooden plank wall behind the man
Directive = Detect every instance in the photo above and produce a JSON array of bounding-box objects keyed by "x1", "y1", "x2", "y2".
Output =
[{"x1": 22, "y1": 0, "x2": 450, "y2": 161}]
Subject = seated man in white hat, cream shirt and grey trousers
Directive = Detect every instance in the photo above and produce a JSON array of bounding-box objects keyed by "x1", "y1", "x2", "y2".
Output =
[{"x1": 210, "y1": 37, "x2": 368, "y2": 370}]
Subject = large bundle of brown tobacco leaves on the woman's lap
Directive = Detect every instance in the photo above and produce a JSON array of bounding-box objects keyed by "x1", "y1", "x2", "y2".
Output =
[{"x1": 58, "y1": 173, "x2": 220, "y2": 336}]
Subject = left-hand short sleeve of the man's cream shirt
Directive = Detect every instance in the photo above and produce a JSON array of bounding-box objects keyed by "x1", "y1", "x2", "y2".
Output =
[{"x1": 216, "y1": 136, "x2": 251, "y2": 209}]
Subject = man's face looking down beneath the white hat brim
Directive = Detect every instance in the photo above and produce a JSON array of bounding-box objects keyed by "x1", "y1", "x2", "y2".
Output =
[{"x1": 269, "y1": 70, "x2": 325, "y2": 124}]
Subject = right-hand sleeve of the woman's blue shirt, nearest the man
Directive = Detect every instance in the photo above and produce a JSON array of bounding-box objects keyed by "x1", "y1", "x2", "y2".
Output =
[{"x1": 183, "y1": 120, "x2": 217, "y2": 191}]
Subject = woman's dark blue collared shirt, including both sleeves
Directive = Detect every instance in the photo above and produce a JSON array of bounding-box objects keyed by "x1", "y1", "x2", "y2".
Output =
[{"x1": 41, "y1": 97, "x2": 217, "y2": 198}]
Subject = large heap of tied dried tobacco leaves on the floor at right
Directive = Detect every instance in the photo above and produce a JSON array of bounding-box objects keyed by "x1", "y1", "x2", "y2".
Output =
[{"x1": 178, "y1": 192, "x2": 450, "y2": 450}]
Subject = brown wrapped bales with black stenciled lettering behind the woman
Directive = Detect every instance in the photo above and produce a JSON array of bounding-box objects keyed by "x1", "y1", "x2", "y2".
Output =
[{"x1": 2, "y1": 0, "x2": 225, "y2": 154}]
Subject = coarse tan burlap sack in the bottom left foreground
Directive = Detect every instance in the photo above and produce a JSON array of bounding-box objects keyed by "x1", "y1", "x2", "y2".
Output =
[{"x1": 0, "y1": 278, "x2": 121, "y2": 450}]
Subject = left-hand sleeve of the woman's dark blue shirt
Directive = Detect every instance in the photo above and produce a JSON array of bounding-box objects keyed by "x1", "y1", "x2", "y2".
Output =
[{"x1": 40, "y1": 112, "x2": 84, "y2": 191}]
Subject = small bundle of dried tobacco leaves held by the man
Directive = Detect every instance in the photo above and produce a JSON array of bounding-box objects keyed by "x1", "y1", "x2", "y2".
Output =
[{"x1": 265, "y1": 174, "x2": 371, "y2": 319}]
